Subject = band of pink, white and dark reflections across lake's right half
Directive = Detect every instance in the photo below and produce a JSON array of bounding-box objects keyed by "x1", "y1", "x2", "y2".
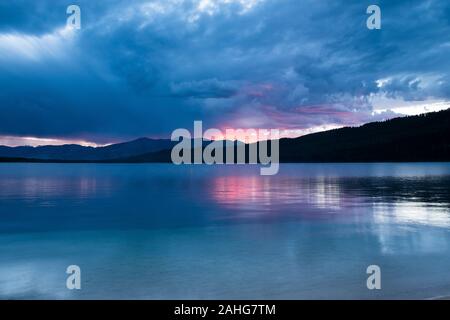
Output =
[{"x1": 209, "y1": 175, "x2": 450, "y2": 227}]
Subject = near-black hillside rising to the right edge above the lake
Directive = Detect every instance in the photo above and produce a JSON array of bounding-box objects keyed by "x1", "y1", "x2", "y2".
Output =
[{"x1": 280, "y1": 109, "x2": 450, "y2": 162}]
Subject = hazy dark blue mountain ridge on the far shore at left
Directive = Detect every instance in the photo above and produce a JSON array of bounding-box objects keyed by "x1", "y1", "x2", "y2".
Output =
[{"x1": 0, "y1": 138, "x2": 174, "y2": 161}]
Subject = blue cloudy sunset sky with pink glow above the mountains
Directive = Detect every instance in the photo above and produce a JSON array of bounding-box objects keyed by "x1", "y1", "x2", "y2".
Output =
[{"x1": 0, "y1": 0, "x2": 450, "y2": 145}]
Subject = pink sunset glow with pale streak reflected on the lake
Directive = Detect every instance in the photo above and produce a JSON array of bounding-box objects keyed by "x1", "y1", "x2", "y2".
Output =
[{"x1": 210, "y1": 175, "x2": 349, "y2": 218}]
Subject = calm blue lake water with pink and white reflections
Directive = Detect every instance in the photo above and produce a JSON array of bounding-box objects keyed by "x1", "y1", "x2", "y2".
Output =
[{"x1": 0, "y1": 163, "x2": 450, "y2": 299}]
